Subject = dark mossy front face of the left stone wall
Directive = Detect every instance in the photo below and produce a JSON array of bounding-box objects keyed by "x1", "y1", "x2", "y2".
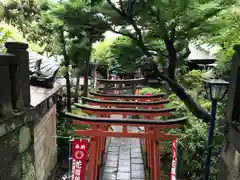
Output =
[{"x1": 0, "y1": 113, "x2": 36, "y2": 180}]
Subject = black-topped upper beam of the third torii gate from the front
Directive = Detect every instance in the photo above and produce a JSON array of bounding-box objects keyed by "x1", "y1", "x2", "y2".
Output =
[{"x1": 82, "y1": 97, "x2": 169, "y2": 105}]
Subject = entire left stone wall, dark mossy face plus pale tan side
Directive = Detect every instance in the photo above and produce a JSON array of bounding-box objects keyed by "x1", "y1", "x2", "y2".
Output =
[{"x1": 0, "y1": 102, "x2": 57, "y2": 180}]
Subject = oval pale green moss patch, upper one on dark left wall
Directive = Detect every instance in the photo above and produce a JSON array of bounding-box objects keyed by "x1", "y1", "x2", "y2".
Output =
[{"x1": 18, "y1": 126, "x2": 31, "y2": 153}]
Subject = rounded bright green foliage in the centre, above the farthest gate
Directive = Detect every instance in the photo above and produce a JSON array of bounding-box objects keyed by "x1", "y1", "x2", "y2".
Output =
[{"x1": 93, "y1": 36, "x2": 144, "y2": 74}]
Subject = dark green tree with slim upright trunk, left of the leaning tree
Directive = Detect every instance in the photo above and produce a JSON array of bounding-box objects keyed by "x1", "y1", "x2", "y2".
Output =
[{"x1": 55, "y1": 0, "x2": 108, "y2": 96}]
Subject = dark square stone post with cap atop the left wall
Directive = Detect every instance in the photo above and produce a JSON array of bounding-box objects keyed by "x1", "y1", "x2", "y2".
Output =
[{"x1": 5, "y1": 42, "x2": 30, "y2": 110}]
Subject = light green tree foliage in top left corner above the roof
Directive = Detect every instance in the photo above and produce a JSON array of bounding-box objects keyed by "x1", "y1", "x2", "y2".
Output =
[{"x1": 0, "y1": 0, "x2": 61, "y2": 56}]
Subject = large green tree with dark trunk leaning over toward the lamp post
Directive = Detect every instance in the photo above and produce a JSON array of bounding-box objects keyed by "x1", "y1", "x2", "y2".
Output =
[{"x1": 98, "y1": 0, "x2": 234, "y2": 122}]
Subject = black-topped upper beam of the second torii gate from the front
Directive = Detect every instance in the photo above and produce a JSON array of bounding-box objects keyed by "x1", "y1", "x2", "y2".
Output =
[{"x1": 74, "y1": 103, "x2": 176, "y2": 113}]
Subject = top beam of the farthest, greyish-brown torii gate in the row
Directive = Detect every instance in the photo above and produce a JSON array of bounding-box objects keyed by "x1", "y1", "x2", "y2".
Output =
[{"x1": 97, "y1": 78, "x2": 146, "y2": 84}]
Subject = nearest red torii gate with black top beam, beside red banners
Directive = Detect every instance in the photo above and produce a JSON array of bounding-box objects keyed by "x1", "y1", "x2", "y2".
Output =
[{"x1": 65, "y1": 113, "x2": 187, "y2": 180}]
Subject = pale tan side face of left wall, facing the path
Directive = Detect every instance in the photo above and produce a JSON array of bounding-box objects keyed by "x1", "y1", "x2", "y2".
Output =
[{"x1": 34, "y1": 106, "x2": 57, "y2": 180}]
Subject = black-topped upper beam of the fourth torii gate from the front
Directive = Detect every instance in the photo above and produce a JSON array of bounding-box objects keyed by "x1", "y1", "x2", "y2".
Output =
[{"x1": 89, "y1": 92, "x2": 166, "y2": 99}]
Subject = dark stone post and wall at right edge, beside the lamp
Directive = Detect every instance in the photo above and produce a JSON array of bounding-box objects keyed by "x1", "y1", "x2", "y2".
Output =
[{"x1": 219, "y1": 45, "x2": 240, "y2": 180}]
